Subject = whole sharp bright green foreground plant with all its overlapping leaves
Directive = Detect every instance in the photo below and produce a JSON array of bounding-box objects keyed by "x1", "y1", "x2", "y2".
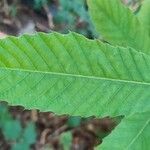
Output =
[{"x1": 0, "y1": 0, "x2": 150, "y2": 150}]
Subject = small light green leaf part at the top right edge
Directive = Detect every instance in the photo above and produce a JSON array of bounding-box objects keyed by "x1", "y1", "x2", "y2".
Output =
[{"x1": 138, "y1": 0, "x2": 150, "y2": 33}]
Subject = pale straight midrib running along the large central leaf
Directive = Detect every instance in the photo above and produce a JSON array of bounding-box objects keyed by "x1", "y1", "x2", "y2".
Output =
[{"x1": 0, "y1": 67, "x2": 150, "y2": 86}]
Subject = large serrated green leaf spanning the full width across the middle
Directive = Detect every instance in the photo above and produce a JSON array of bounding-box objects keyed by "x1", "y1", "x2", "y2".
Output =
[{"x1": 0, "y1": 33, "x2": 150, "y2": 117}]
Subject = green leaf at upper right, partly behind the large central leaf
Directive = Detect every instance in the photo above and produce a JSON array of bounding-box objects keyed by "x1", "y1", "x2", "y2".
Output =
[{"x1": 88, "y1": 0, "x2": 150, "y2": 54}]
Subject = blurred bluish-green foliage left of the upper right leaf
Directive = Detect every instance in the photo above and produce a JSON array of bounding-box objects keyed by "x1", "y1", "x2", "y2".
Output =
[{"x1": 54, "y1": 0, "x2": 97, "y2": 38}]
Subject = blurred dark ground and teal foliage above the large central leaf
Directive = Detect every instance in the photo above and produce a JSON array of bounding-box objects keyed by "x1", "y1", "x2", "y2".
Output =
[{"x1": 0, "y1": 0, "x2": 96, "y2": 38}]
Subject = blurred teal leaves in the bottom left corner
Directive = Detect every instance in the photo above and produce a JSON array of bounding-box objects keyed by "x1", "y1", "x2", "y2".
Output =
[{"x1": 0, "y1": 104, "x2": 36, "y2": 150}]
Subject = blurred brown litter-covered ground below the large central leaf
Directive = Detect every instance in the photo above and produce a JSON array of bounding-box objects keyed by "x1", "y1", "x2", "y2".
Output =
[{"x1": 0, "y1": 103, "x2": 121, "y2": 150}]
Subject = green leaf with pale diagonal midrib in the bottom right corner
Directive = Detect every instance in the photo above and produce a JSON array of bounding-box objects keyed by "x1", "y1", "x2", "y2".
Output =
[{"x1": 97, "y1": 112, "x2": 150, "y2": 150}]
